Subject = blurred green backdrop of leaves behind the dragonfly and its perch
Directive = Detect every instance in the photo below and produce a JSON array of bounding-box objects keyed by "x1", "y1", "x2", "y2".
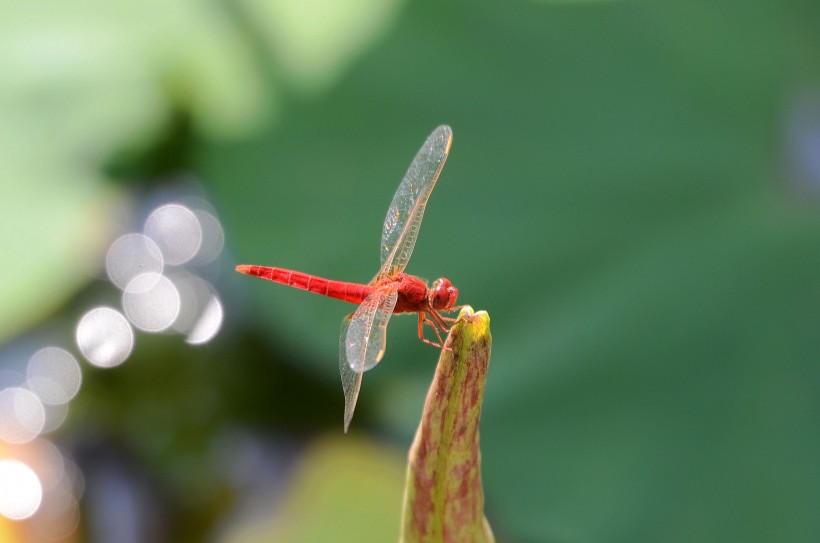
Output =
[{"x1": 0, "y1": 0, "x2": 820, "y2": 543}]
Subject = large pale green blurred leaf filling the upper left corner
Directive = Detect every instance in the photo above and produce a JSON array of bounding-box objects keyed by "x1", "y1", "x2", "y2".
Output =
[{"x1": 0, "y1": 0, "x2": 266, "y2": 338}]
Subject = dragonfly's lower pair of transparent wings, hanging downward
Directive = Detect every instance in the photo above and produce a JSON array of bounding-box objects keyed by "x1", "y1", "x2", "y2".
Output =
[{"x1": 339, "y1": 289, "x2": 398, "y2": 433}]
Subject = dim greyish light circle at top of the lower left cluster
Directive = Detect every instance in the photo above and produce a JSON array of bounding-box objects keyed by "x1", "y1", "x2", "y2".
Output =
[{"x1": 28, "y1": 347, "x2": 82, "y2": 405}]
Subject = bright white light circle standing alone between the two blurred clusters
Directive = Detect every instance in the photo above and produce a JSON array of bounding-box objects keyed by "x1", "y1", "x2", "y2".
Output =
[{"x1": 77, "y1": 307, "x2": 134, "y2": 368}]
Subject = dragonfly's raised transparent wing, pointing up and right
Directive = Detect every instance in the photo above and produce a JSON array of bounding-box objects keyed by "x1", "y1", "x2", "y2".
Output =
[{"x1": 379, "y1": 125, "x2": 453, "y2": 275}]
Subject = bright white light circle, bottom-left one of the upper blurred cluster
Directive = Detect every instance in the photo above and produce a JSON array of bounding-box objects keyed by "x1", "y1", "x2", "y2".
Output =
[{"x1": 122, "y1": 273, "x2": 180, "y2": 332}]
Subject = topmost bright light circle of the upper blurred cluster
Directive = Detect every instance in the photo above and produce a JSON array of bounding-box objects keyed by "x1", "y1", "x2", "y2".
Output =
[{"x1": 144, "y1": 204, "x2": 202, "y2": 266}]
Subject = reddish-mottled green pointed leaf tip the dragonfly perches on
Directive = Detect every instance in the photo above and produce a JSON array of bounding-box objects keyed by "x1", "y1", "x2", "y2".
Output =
[{"x1": 400, "y1": 306, "x2": 495, "y2": 543}]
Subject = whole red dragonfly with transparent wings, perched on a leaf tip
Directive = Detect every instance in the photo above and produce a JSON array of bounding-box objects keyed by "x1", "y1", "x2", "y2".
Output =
[{"x1": 236, "y1": 125, "x2": 458, "y2": 432}]
